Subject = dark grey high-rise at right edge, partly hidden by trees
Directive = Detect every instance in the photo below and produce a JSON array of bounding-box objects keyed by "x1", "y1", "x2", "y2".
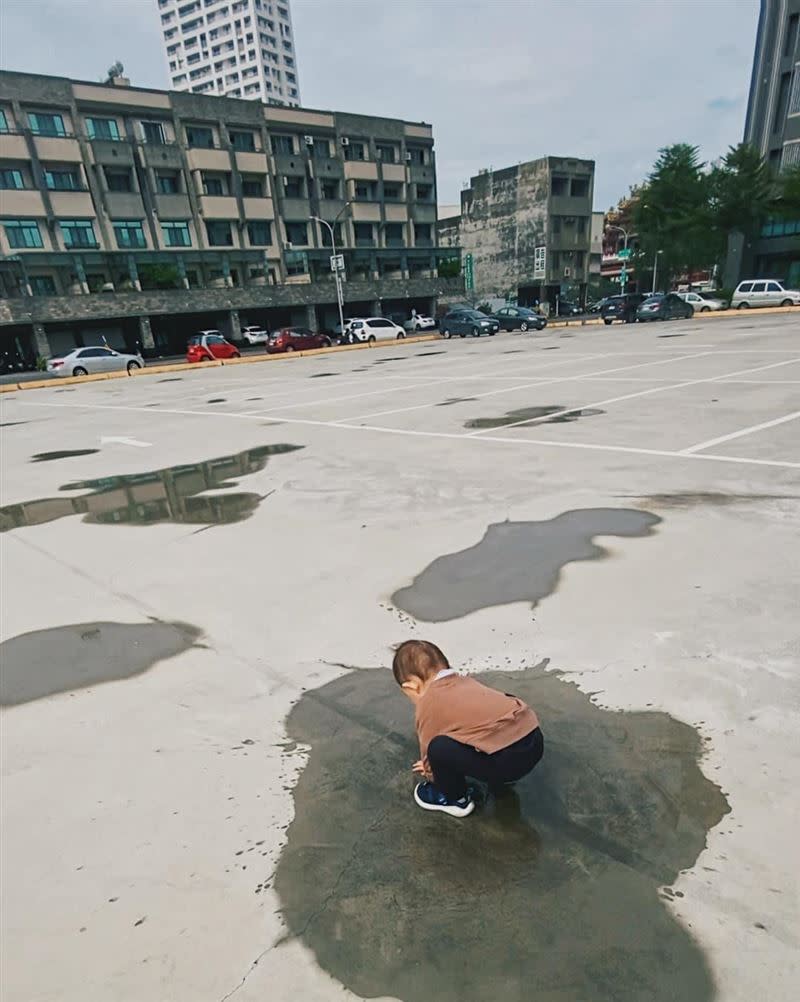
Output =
[{"x1": 725, "y1": 0, "x2": 800, "y2": 288}]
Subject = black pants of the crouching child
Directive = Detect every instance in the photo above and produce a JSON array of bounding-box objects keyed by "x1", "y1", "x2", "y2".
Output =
[{"x1": 428, "y1": 727, "x2": 544, "y2": 801}]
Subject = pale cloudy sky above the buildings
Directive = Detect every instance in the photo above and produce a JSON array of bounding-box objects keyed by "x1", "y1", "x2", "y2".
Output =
[{"x1": 0, "y1": 0, "x2": 758, "y2": 209}]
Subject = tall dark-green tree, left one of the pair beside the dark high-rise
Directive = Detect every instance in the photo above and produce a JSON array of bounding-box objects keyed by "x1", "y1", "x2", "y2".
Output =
[{"x1": 634, "y1": 142, "x2": 722, "y2": 288}]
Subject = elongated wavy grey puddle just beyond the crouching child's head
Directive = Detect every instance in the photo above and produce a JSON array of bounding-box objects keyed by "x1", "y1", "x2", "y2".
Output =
[{"x1": 392, "y1": 508, "x2": 661, "y2": 622}]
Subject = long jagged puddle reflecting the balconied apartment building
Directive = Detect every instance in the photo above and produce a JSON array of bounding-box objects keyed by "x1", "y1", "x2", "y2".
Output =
[{"x1": 0, "y1": 445, "x2": 303, "y2": 532}]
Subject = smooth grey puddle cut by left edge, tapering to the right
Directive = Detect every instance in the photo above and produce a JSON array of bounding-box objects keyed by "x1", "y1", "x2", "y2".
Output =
[{"x1": 0, "y1": 620, "x2": 202, "y2": 706}]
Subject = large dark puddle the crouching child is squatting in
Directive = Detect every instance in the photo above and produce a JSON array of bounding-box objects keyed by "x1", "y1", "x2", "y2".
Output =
[{"x1": 275, "y1": 668, "x2": 729, "y2": 1002}]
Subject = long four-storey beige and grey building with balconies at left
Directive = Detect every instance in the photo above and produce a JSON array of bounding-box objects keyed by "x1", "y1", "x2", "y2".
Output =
[{"x1": 0, "y1": 72, "x2": 462, "y2": 368}]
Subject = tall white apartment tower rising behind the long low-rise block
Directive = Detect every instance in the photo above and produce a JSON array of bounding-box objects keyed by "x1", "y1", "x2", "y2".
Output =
[{"x1": 155, "y1": 0, "x2": 300, "y2": 106}]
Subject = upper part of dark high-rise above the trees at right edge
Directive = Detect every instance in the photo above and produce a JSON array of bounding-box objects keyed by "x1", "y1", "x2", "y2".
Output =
[{"x1": 744, "y1": 0, "x2": 800, "y2": 170}]
